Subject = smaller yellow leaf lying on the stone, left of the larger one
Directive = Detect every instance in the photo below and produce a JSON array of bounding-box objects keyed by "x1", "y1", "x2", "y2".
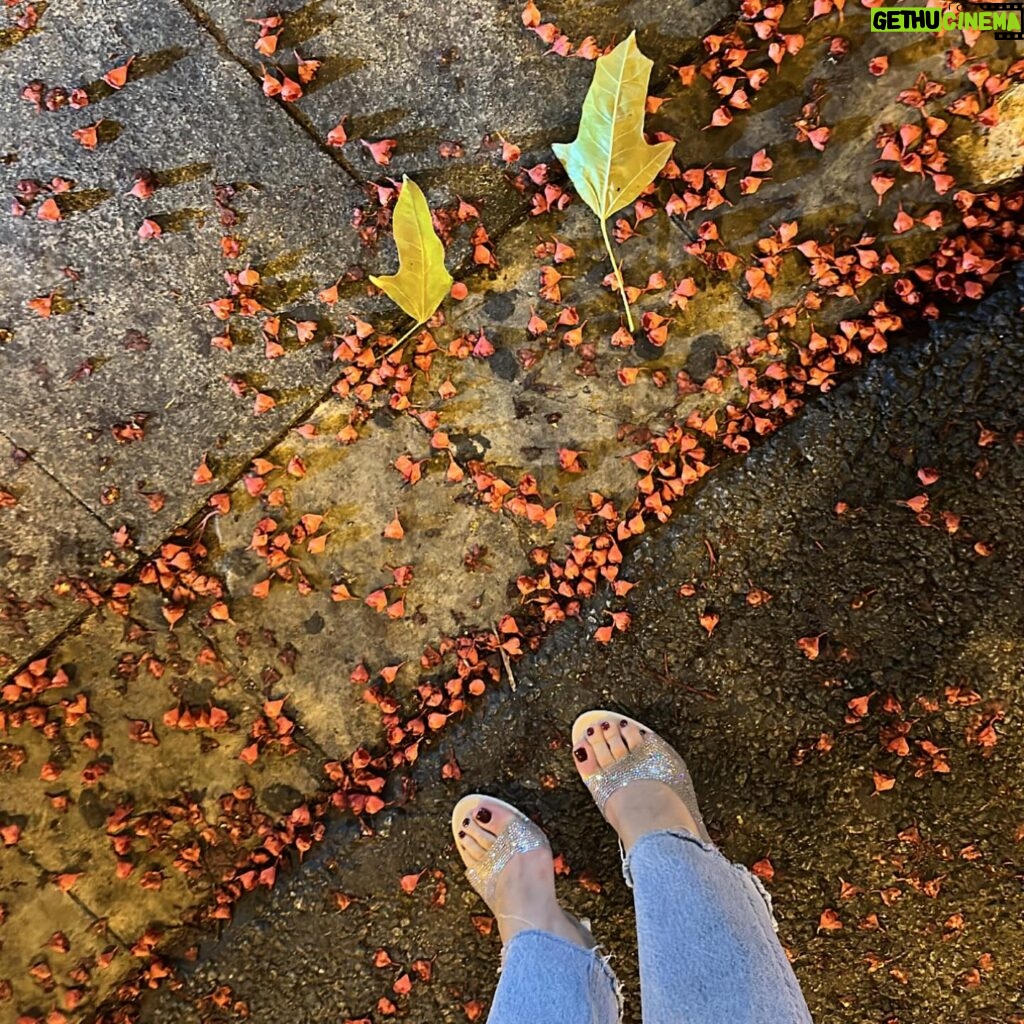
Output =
[{"x1": 370, "y1": 175, "x2": 453, "y2": 325}]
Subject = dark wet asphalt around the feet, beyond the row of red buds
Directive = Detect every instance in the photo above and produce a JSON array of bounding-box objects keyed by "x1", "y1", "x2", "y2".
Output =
[{"x1": 143, "y1": 272, "x2": 1024, "y2": 1024}]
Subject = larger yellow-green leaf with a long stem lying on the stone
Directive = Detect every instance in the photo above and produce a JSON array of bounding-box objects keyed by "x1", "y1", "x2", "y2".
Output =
[{"x1": 554, "y1": 33, "x2": 672, "y2": 330}]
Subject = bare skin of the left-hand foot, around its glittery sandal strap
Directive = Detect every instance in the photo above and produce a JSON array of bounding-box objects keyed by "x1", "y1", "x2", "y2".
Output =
[{"x1": 457, "y1": 799, "x2": 593, "y2": 949}]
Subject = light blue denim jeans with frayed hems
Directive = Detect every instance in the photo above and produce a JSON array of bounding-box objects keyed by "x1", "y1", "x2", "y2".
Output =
[{"x1": 487, "y1": 829, "x2": 812, "y2": 1024}]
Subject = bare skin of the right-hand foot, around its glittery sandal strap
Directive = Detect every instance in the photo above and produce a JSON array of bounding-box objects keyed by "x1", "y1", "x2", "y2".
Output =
[{"x1": 572, "y1": 716, "x2": 700, "y2": 851}]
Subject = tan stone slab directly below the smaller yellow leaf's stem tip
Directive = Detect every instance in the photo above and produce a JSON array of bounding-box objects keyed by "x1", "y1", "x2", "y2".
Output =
[{"x1": 209, "y1": 399, "x2": 535, "y2": 758}]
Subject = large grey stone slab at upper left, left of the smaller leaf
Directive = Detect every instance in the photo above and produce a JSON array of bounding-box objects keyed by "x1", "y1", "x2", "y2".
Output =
[{"x1": 0, "y1": 0, "x2": 370, "y2": 577}]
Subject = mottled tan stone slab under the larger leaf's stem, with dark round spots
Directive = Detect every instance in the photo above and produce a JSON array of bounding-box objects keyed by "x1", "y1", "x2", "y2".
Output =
[{"x1": 414, "y1": 202, "x2": 762, "y2": 550}]
